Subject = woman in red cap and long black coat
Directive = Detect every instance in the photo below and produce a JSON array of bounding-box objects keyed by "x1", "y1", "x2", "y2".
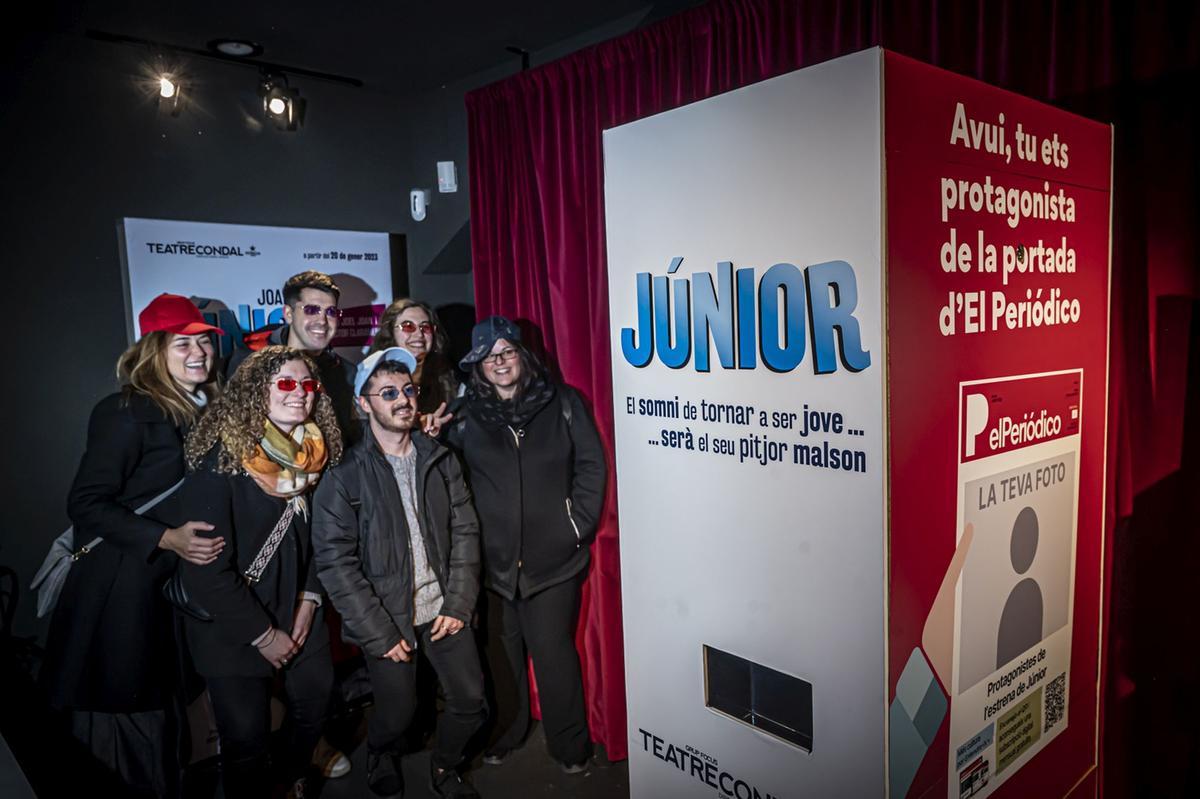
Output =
[{"x1": 40, "y1": 294, "x2": 222, "y2": 795}]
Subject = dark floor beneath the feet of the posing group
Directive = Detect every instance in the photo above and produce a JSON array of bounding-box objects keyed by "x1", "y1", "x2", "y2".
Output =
[{"x1": 318, "y1": 725, "x2": 629, "y2": 799}]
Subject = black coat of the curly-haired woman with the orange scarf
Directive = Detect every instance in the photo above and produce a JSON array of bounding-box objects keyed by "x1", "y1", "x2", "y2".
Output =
[{"x1": 179, "y1": 456, "x2": 329, "y2": 677}]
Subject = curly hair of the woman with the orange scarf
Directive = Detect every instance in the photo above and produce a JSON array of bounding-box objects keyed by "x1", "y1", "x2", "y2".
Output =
[{"x1": 184, "y1": 346, "x2": 342, "y2": 474}]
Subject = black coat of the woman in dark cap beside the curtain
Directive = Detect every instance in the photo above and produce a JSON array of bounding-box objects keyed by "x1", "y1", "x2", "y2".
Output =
[{"x1": 450, "y1": 385, "x2": 605, "y2": 599}]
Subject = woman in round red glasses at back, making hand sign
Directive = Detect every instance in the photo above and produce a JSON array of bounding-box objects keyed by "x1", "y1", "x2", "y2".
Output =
[{"x1": 367, "y1": 299, "x2": 461, "y2": 414}]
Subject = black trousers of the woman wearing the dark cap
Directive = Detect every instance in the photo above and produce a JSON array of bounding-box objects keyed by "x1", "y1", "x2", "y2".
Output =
[{"x1": 487, "y1": 575, "x2": 590, "y2": 765}]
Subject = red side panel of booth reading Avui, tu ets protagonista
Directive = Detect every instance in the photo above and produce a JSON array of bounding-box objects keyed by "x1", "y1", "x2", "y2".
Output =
[{"x1": 884, "y1": 53, "x2": 1112, "y2": 799}]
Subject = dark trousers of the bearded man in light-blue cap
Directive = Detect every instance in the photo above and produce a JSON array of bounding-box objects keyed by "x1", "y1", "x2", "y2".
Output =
[{"x1": 366, "y1": 624, "x2": 487, "y2": 769}]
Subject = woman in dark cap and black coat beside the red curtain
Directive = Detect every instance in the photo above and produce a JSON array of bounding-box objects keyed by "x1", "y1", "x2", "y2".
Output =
[{"x1": 450, "y1": 317, "x2": 605, "y2": 774}]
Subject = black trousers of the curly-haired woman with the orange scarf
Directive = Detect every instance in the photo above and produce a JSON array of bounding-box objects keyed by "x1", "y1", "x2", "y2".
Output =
[{"x1": 205, "y1": 644, "x2": 334, "y2": 799}]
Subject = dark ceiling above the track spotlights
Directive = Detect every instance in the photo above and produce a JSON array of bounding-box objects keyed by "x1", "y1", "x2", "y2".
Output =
[{"x1": 54, "y1": 0, "x2": 700, "y2": 94}]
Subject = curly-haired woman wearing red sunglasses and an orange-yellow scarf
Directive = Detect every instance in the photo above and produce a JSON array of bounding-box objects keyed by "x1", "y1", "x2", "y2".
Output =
[{"x1": 180, "y1": 347, "x2": 342, "y2": 799}]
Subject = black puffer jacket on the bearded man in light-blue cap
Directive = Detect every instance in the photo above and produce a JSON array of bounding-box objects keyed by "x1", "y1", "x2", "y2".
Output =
[{"x1": 312, "y1": 425, "x2": 479, "y2": 657}]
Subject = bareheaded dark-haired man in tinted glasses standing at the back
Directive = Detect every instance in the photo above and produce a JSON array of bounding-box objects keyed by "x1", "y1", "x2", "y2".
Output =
[{"x1": 226, "y1": 270, "x2": 358, "y2": 443}]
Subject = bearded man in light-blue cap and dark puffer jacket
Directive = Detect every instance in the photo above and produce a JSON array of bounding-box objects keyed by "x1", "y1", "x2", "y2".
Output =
[{"x1": 312, "y1": 347, "x2": 486, "y2": 798}]
